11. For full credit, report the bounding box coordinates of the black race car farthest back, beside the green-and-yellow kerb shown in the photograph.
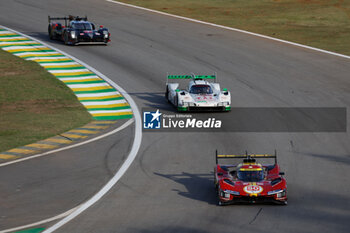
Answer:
[48,16,110,45]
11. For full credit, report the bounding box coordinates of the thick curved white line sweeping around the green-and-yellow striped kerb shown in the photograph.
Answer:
[0,25,142,233]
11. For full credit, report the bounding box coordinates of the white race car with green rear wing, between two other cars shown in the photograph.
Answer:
[165,75,231,111]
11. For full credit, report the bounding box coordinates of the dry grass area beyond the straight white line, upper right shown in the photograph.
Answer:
[120,0,350,55]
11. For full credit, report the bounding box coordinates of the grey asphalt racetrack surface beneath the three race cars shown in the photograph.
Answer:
[0,0,350,233]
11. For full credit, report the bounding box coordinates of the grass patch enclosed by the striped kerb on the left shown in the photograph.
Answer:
[0,50,92,152]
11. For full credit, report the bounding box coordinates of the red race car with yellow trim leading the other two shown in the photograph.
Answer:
[214,151,287,205]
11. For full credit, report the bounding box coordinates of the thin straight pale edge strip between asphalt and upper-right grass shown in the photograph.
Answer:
[106,0,350,59]
